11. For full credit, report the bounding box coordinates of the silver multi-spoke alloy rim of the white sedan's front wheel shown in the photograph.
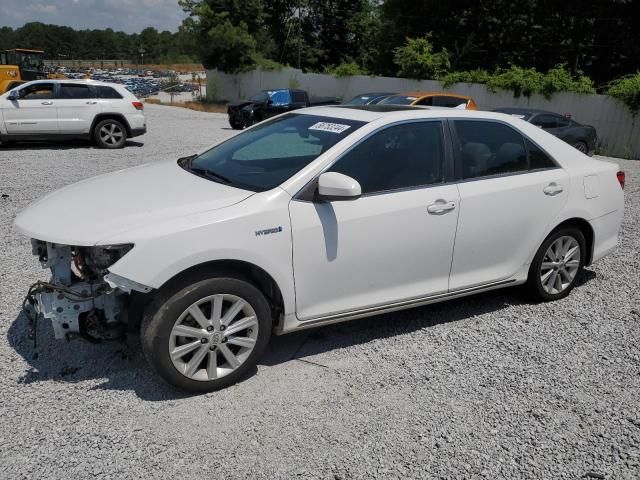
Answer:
[169,294,258,381]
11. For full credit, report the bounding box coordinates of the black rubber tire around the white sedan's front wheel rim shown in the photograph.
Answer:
[141,276,272,393]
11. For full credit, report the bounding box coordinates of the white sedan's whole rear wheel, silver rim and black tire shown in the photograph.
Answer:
[527,227,586,302]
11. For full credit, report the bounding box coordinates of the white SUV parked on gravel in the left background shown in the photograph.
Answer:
[0,80,147,148]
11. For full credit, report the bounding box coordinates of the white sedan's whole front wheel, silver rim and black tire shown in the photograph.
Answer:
[142,277,271,392]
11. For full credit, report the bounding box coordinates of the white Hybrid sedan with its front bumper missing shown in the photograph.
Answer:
[15,106,624,391]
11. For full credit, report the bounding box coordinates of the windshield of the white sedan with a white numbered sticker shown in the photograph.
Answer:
[179,113,364,192]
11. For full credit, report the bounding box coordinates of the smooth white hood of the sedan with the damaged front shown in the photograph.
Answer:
[15,160,254,246]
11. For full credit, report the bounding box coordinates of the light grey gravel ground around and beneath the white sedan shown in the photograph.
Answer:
[0,105,640,480]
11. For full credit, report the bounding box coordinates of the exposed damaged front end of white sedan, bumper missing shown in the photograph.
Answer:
[23,239,151,343]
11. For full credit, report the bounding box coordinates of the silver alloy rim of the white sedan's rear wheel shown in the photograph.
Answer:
[540,236,580,295]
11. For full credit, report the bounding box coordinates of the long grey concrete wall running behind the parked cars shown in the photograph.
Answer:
[207,68,640,159]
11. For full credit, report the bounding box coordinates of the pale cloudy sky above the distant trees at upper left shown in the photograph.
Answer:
[0,0,185,33]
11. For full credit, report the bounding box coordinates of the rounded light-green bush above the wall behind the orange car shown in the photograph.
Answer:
[393,34,451,79]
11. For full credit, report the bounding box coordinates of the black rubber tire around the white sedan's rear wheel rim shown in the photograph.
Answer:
[526,226,587,302]
